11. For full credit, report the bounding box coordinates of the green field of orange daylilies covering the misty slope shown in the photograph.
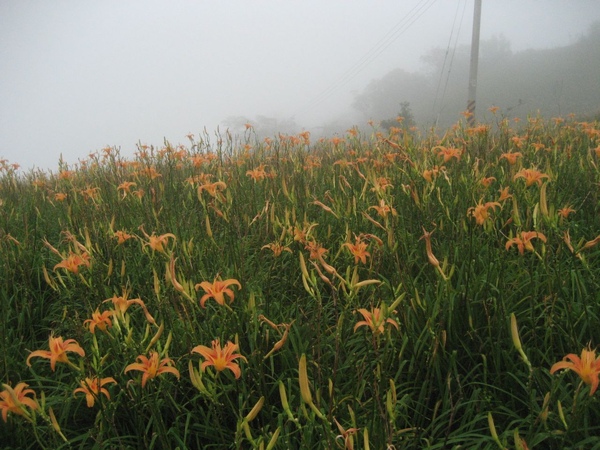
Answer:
[0,109,600,450]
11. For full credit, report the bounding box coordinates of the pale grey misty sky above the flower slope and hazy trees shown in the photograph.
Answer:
[0,0,600,171]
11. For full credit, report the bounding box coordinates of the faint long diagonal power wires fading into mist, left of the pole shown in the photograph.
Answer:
[293,0,437,115]
